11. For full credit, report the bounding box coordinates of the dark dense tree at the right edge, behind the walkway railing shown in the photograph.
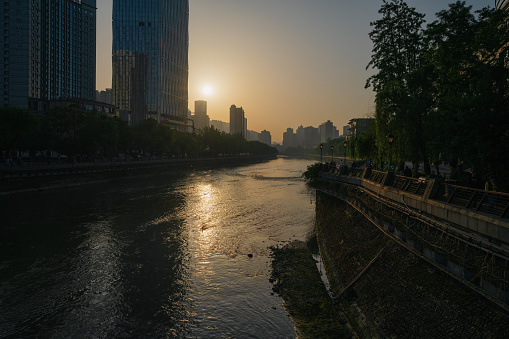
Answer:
[426,1,509,189]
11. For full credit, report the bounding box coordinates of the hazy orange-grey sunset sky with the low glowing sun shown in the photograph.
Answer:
[97,0,488,142]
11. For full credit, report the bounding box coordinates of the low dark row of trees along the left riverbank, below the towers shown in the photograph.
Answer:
[0,106,277,159]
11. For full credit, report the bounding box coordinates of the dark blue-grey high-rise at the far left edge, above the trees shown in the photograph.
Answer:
[0,0,96,110]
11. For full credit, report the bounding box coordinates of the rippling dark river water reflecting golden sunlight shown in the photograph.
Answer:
[0,158,315,338]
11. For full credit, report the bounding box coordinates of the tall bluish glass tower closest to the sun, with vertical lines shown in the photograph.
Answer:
[112,0,189,129]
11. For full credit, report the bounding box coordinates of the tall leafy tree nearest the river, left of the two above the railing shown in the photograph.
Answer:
[366,0,430,172]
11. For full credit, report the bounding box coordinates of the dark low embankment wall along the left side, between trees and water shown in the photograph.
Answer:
[0,155,277,196]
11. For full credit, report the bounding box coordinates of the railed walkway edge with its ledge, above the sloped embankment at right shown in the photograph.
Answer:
[317,165,509,311]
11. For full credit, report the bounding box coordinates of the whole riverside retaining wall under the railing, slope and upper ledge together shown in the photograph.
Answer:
[316,178,509,337]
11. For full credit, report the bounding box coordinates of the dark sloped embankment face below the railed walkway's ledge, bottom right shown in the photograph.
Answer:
[316,191,509,338]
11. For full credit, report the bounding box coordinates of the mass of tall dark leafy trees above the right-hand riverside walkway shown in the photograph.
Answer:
[342,0,509,187]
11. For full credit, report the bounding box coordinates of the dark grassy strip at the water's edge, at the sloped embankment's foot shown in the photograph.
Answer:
[271,241,351,338]
